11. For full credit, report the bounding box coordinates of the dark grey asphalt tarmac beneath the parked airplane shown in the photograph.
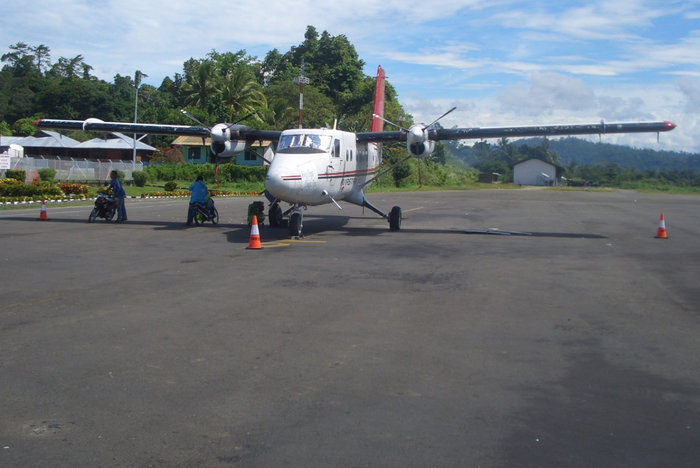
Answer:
[0,189,700,467]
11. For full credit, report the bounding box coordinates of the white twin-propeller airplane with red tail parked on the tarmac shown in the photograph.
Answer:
[35,66,676,238]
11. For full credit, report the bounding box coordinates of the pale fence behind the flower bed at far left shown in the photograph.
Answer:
[0,155,143,181]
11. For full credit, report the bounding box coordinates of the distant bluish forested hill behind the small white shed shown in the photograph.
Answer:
[513,137,700,172]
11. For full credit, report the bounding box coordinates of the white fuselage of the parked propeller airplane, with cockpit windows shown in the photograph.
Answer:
[265,129,381,206]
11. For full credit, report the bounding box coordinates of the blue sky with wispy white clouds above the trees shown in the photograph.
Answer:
[0,0,700,152]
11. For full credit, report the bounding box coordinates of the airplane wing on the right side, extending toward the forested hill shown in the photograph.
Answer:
[357,121,676,142]
